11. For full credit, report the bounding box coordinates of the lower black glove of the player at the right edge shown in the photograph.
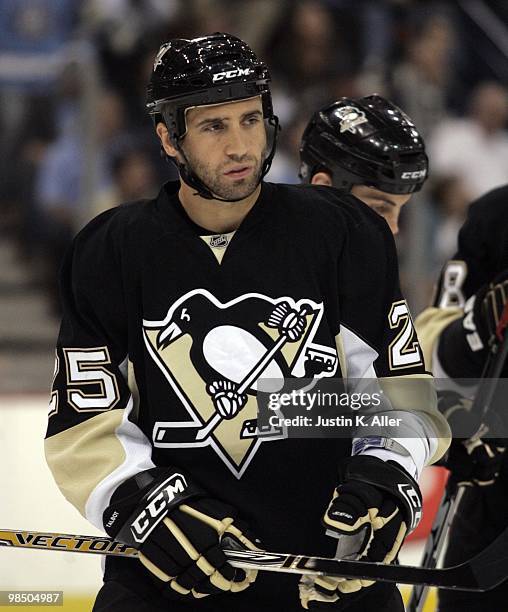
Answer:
[437,391,506,487]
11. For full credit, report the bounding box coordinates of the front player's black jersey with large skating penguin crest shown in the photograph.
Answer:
[45,183,448,610]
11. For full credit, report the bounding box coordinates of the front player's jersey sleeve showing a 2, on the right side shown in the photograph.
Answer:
[338,203,449,472]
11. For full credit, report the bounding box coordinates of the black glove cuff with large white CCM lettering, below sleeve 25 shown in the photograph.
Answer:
[103,468,205,548]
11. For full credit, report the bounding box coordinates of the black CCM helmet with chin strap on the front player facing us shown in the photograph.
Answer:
[146,32,278,199]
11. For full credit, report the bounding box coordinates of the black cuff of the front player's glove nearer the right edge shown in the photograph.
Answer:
[339,455,422,532]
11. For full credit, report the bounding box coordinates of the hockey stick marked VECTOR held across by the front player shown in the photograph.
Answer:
[0,529,508,591]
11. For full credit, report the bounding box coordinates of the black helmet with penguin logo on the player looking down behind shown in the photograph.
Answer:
[300,94,428,194]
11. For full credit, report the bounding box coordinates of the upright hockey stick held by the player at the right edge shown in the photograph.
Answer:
[408,304,508,612]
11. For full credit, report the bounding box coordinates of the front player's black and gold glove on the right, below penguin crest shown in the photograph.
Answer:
[300,455,422,611]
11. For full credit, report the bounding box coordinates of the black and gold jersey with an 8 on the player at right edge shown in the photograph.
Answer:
[416,186,508,376]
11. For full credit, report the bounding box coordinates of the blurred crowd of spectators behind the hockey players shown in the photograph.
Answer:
[0,0,508,391]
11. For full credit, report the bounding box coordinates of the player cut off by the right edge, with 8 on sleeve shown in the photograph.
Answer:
[416,186,508,612]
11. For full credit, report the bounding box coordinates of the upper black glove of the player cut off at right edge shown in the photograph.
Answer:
[438,270,508,378]
